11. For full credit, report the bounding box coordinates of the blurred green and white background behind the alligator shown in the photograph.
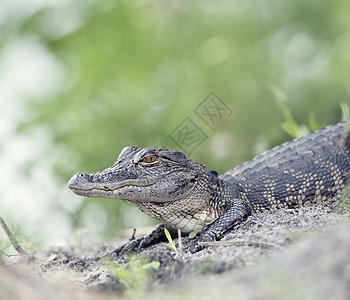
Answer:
[0,0,350,244]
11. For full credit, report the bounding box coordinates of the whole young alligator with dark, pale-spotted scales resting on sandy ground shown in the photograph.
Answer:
[68,122,350,254]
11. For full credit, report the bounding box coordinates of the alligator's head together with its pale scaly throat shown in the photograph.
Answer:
[68,146,227,233]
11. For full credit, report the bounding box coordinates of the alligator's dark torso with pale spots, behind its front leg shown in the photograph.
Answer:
[221,122,350,211]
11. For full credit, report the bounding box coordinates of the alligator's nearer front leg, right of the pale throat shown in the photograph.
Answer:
[187,199,252,253]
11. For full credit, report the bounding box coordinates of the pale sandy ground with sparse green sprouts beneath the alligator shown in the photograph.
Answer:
[0,197,350,300]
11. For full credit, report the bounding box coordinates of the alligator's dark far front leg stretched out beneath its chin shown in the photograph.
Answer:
[111,224,177,256]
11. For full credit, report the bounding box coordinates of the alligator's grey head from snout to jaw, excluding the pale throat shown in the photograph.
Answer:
[68,146,212,202]
